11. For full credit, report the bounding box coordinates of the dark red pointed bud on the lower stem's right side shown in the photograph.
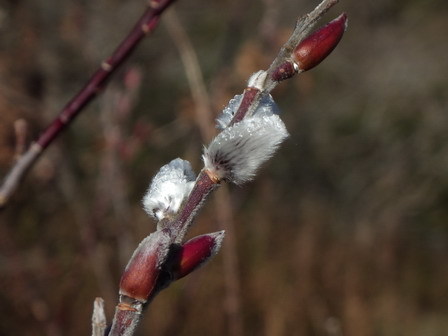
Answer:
[172,231,225,279]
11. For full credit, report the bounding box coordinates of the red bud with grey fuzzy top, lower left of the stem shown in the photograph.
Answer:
[120,230,170,302]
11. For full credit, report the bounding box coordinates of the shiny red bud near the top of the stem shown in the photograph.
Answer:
[292,13,347,72]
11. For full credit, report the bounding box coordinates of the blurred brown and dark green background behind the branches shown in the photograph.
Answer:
[0,0,448,336]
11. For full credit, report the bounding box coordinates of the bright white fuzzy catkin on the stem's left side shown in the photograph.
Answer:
[143,159,196,221]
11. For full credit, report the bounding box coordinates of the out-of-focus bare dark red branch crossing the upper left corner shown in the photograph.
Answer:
[0,0,175,208]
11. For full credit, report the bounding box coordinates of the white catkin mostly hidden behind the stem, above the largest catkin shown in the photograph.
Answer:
[216,94,280,131]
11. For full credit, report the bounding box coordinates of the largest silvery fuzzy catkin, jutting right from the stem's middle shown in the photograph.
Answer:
[202,114,288,184]
